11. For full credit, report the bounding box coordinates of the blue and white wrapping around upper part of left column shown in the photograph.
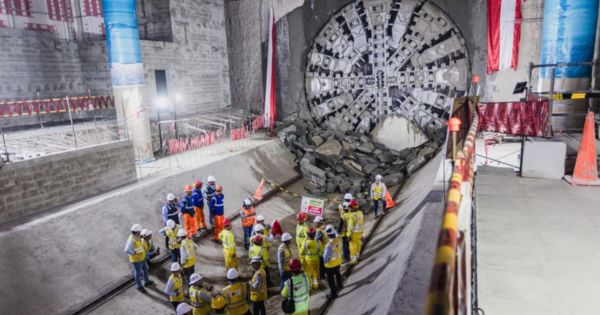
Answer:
[102,0,144,87]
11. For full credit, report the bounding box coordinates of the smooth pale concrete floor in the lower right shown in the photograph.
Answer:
[476,167,600,314]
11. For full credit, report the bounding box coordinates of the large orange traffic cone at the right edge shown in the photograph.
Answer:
[565,112,600,186]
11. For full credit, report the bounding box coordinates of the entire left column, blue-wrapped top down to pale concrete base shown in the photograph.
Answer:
[102,0,154,163]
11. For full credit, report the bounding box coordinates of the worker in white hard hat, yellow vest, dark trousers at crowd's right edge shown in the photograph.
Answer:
[323,225,342,299]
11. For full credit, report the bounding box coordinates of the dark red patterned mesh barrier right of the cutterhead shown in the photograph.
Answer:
[477,100,549,137]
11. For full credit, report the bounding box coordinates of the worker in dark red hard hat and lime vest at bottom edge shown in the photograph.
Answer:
[281,258,311,315]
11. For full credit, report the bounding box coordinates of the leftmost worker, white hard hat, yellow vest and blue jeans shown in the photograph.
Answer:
[125,224,154,292]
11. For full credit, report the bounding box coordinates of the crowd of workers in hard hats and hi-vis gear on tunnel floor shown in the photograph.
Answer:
[125,175,387,315]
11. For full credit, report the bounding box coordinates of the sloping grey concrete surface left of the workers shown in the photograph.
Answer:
[0,141,297,314]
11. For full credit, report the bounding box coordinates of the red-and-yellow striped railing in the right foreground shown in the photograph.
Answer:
[425,110,479,315]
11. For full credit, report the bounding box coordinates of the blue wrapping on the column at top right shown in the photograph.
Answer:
[540,0,598,78]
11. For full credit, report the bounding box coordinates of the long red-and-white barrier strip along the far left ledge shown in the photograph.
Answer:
[0,95,115,118]
